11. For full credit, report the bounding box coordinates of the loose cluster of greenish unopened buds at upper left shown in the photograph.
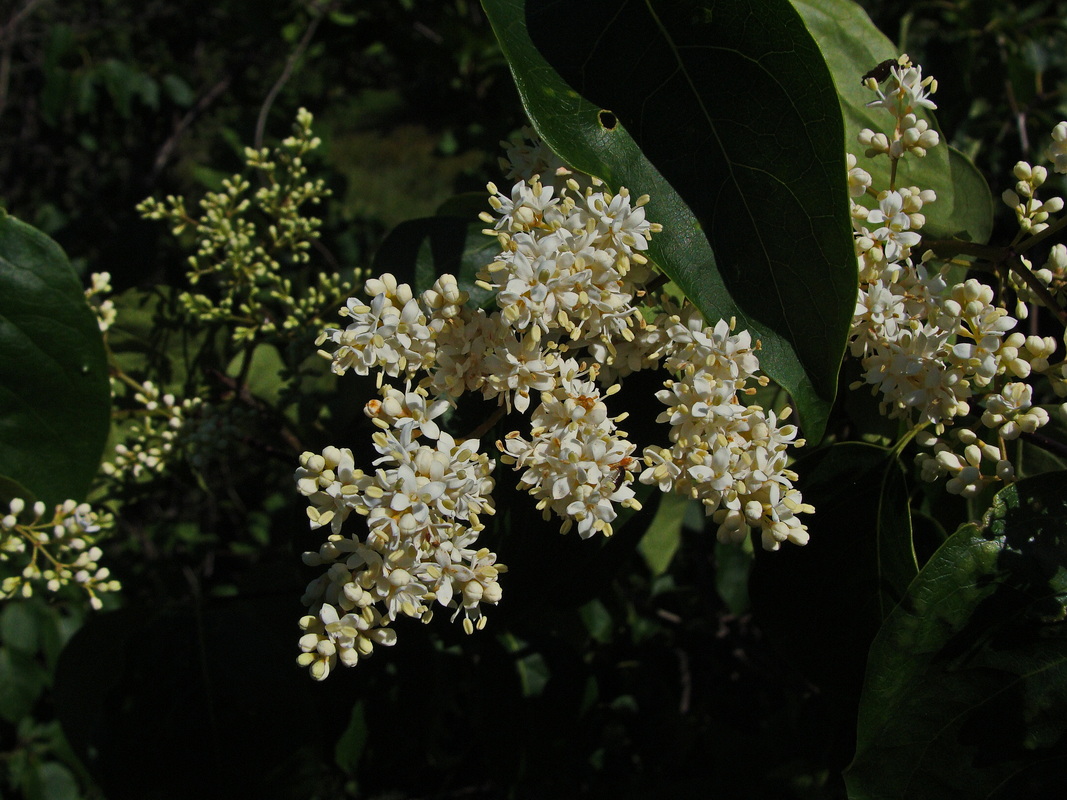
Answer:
[138,109,356,342]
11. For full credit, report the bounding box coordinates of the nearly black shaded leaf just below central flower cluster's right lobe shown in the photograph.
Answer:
[748,443,917,695]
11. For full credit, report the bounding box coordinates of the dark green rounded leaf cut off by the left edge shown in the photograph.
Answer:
[0,212,111,503]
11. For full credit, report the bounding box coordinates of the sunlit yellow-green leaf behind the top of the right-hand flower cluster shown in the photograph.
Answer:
[793,0,993,242]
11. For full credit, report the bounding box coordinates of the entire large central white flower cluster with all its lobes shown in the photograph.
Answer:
[297,134,812,679]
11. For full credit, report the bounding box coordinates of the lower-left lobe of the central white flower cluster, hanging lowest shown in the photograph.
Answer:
[297,413,507,681]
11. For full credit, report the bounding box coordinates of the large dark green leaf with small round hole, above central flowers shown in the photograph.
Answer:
[482,0,856,439]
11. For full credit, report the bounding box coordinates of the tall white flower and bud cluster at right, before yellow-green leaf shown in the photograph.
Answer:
[848,55,1063,496]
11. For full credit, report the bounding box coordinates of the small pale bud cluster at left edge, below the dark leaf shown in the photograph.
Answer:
[0,497,122,609]
